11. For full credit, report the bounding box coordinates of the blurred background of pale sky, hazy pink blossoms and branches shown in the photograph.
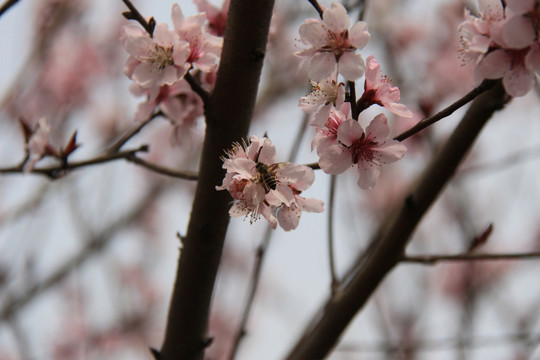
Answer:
[0,0,540,360]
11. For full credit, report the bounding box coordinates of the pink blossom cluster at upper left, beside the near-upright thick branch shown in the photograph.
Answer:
[120,0,224,142]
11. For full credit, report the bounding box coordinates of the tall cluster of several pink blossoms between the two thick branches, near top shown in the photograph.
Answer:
[297,3,413,189]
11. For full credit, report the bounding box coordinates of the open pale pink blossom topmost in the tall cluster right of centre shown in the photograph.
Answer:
[295,3,370,81]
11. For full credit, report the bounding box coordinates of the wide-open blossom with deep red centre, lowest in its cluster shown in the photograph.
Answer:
[319,114,407,189]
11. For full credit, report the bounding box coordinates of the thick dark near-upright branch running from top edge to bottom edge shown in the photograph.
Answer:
[161,0,273,360]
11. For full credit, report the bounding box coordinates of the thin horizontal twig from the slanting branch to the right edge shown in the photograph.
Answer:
[400,252,540,265]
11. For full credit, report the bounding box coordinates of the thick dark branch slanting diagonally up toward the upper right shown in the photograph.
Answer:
[287,83,506,360]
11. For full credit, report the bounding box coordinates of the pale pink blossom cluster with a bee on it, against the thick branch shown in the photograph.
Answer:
[216,136,324,231]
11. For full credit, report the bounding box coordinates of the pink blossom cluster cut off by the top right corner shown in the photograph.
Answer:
[460,0,540,96]
